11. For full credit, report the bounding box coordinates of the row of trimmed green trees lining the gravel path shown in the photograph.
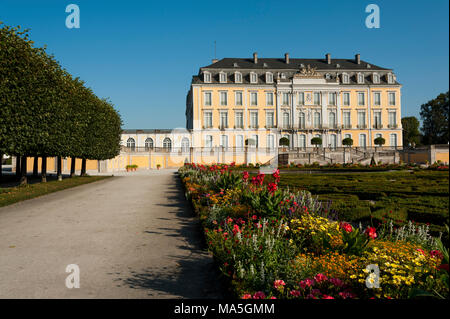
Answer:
[0,22,122,183]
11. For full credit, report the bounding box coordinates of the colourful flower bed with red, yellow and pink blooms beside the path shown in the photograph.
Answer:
[179,164,448,299]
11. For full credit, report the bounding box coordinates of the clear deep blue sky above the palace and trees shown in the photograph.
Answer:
[0,0,449,128]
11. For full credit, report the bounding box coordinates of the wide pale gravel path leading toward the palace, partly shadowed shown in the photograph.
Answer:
[0,170,223,298]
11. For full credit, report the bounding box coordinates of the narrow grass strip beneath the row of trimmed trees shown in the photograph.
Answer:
[0,176,110,207]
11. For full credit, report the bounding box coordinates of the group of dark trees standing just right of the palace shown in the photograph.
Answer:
[402,92,449,146]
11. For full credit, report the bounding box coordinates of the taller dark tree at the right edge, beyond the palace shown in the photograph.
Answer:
[420,92,449,144]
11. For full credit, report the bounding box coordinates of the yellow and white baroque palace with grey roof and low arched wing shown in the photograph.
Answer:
[114,53,402,169]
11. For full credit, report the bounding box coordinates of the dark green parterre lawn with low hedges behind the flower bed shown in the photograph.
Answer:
[279,170,449,232]
